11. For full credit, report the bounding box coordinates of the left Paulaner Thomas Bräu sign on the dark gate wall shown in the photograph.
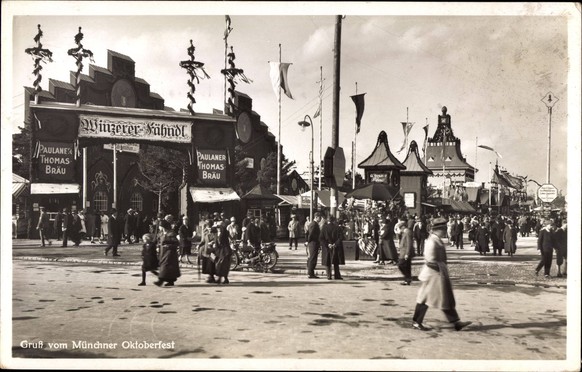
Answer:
[37,141,75,182]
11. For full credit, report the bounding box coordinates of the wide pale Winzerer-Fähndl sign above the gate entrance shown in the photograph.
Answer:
[79,115,192,143]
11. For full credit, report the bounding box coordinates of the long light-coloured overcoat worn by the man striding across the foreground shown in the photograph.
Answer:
[416,234,456,310]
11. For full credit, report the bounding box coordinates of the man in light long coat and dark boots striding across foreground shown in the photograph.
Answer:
[412,218,472,331]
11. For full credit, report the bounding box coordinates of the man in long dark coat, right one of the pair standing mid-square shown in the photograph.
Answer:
[319,216,346,280]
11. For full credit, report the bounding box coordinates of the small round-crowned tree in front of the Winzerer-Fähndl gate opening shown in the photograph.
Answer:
[137,145,188,213]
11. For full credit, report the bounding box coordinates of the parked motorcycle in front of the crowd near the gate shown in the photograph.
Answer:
[230,240,279,273]
